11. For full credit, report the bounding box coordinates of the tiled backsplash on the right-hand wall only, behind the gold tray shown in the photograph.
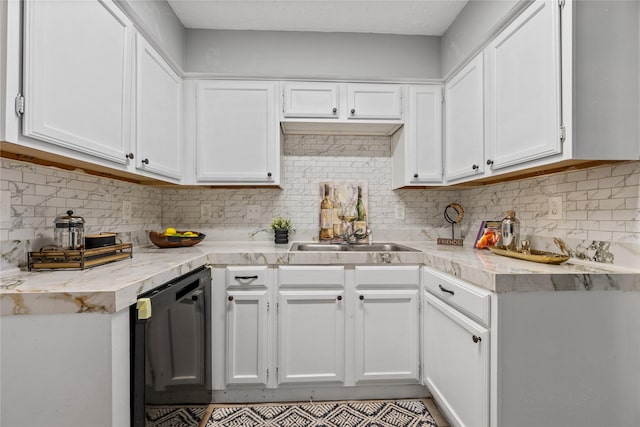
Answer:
[461,161,640,268]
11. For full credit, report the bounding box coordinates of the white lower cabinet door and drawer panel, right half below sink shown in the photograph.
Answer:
[354,266,420,383]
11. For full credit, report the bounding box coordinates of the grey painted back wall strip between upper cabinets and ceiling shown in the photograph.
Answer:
[185,30,440,81]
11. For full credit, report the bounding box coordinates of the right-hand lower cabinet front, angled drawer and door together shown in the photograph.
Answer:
[422,268,491,427]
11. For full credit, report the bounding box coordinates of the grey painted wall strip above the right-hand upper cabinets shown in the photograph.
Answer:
[441,0,529,77]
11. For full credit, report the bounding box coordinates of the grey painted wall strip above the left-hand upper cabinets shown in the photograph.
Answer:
[124,0,186,69]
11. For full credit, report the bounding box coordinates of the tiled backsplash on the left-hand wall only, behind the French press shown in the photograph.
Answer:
[0,159,162,268]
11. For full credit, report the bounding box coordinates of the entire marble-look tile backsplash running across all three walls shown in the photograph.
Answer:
[0,150,640,268]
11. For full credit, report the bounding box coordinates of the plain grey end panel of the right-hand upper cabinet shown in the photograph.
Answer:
[573,0,640,158]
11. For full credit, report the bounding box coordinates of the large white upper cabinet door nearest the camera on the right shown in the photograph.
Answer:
[486,0,562,169]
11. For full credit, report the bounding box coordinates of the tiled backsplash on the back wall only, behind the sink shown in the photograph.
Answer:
[162,135,460,240]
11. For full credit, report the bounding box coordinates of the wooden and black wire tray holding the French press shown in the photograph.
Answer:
[28,243,133,271]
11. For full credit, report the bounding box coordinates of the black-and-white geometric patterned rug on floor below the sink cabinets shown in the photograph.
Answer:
[205,400,436,427]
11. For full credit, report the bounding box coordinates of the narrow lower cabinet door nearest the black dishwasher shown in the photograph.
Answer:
[226,289,268,386]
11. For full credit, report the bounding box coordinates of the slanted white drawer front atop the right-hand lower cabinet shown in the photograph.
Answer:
[424,268,491,326]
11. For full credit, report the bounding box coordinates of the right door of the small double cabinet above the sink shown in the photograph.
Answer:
[347,84,402,120]
